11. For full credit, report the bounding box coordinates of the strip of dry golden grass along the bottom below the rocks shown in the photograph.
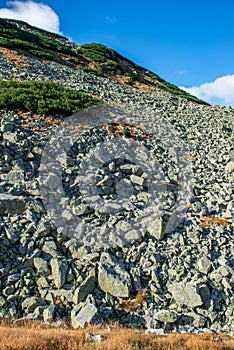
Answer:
[0,324,234,350]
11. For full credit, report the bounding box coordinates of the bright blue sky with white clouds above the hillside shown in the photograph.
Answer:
[0,0,234,106]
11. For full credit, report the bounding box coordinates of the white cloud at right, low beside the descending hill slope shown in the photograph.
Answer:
[180,74,234,107]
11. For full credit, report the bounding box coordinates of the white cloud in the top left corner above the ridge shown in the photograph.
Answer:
[0,0,62,34]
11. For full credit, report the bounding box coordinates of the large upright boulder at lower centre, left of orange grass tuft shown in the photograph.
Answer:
[98,253,131,298]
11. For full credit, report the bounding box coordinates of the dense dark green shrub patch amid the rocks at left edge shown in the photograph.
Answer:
[0,81,100,116]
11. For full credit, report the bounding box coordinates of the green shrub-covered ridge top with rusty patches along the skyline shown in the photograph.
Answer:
[0,19,207,104]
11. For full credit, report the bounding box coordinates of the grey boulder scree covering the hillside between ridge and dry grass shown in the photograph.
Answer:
[0,20,234,334]
